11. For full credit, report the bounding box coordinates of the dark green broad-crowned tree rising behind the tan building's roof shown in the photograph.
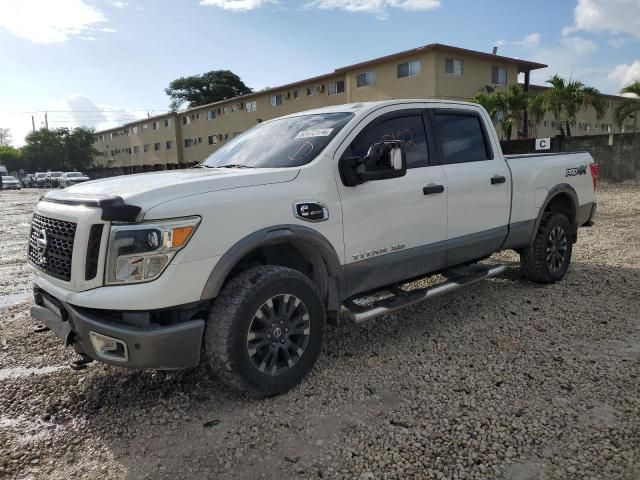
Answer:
[165,70,252,111]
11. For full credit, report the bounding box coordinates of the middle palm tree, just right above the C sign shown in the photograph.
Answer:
[542,74,605,137]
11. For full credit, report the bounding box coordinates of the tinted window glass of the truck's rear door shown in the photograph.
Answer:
[434,113,492,163]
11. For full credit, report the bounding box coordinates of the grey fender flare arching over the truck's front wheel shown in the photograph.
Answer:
[200,224,344,310]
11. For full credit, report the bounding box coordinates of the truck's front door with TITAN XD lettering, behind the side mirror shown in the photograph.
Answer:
[334,104,447,294]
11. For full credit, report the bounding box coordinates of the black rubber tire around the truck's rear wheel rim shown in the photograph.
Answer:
[520,212,573,283]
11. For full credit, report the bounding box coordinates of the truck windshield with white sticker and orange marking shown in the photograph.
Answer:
[202,112,353,168]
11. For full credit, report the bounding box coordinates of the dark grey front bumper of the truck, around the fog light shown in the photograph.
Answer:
[31,291,204,370]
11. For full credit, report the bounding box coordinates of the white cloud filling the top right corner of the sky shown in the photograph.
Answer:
[563,0,640,37]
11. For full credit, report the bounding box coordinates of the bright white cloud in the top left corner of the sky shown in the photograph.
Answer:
[0,0,107,44]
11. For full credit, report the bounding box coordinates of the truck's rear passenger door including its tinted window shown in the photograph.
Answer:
[430,107,511,265]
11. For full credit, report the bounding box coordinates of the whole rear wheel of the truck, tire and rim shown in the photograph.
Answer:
[520,212,573,283]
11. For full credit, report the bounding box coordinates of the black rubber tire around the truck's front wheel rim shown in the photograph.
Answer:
[203,265,325,398]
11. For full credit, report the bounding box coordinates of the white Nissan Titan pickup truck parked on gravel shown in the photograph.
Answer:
[28,100,598,396]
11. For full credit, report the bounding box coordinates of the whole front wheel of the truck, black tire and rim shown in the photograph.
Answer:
[204,265,325,397]
